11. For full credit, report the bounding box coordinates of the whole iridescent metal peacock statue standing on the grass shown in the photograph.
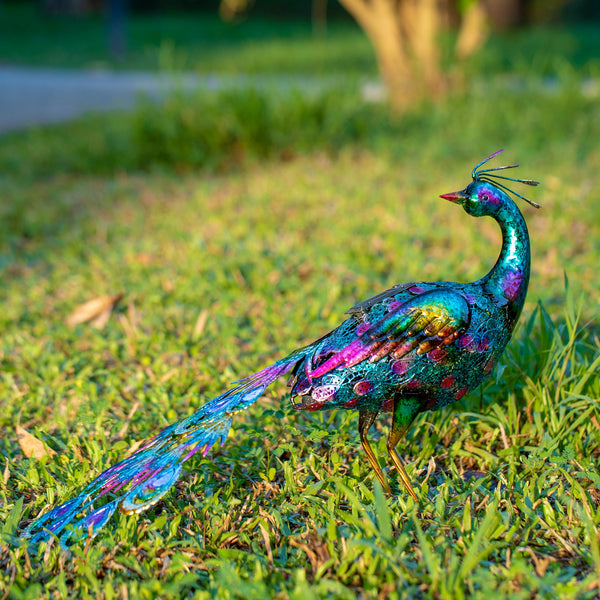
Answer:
[25,151,539,542]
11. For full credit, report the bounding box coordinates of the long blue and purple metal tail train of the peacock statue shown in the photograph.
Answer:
[24,349,306,544]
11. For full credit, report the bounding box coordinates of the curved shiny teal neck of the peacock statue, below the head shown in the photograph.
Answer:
[478,200,531,325]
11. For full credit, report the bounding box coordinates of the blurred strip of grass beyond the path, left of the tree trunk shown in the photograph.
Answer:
[0,3,377,76]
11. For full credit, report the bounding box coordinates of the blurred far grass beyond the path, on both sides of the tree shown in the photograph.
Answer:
[0,2,600,79]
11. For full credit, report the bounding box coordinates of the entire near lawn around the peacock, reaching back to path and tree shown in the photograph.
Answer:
[0,5,600,599]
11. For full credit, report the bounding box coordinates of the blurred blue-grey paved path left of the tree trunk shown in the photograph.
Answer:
[0,66,335,134]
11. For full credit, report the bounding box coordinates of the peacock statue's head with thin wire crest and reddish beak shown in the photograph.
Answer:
[440,150,540,217]
